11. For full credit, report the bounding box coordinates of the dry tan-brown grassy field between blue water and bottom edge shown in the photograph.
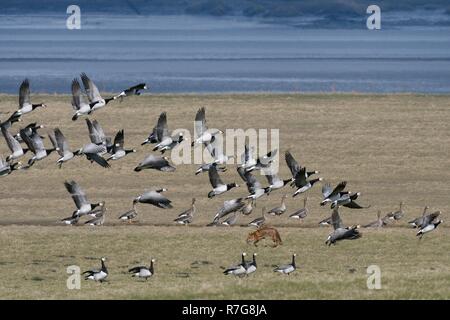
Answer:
[0,94,450,299]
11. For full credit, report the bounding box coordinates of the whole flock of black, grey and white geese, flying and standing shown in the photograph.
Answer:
[0,73,442,281]
